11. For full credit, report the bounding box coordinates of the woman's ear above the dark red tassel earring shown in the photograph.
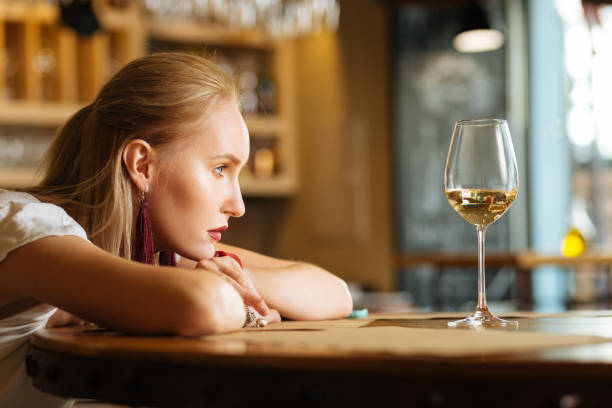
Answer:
[122,139,155,193]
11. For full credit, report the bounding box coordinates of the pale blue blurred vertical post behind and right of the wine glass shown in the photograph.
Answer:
[528,0,571,312]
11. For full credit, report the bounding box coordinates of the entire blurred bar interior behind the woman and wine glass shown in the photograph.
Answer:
[0,0,612,312]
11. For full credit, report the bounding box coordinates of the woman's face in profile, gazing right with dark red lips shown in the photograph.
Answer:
[149,101,249,261]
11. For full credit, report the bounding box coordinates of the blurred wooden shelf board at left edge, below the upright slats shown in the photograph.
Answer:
[0,101,82,127]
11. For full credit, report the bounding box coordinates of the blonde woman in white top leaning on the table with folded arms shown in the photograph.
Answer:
[0,53,352,407]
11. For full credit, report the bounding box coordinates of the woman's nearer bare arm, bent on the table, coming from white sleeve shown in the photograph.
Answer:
[0,236,245,335]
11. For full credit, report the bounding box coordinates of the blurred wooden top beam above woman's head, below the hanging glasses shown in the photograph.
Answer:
[146,18,275,49]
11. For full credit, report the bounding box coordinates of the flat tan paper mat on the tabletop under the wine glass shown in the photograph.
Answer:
[205,321,607,357]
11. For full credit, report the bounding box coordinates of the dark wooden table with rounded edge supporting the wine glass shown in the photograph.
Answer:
[27,311,612,408]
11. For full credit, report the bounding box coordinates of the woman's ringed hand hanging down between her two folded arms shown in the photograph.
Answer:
[195,256,270,322]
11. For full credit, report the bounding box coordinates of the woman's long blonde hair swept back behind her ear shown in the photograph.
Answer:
[28,52,239,259]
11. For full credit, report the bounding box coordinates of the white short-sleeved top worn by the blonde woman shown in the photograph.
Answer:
[0,189,87,408]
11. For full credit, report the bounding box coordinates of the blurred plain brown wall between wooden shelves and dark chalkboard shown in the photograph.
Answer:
[225,0,395,290]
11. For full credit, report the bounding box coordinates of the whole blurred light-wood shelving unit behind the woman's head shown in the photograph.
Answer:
[0,0,297,196]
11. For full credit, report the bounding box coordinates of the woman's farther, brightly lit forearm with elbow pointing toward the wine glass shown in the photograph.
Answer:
[181,244,353,320]
